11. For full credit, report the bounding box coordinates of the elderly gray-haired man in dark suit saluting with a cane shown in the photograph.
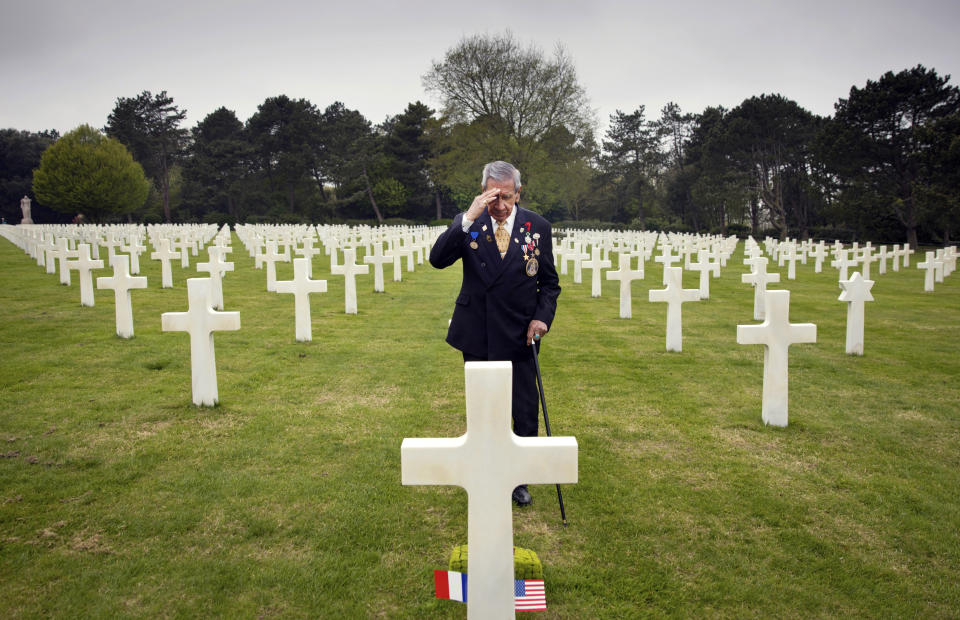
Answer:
[430,161,560,506]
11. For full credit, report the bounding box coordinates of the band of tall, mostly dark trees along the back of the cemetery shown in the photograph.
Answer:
[0,32,960,245]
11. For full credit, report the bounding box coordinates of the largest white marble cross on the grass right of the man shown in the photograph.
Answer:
[737,291,817,426]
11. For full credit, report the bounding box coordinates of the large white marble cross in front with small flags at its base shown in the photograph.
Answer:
[400,362,577,620]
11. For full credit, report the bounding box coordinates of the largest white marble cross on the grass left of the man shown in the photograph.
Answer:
[160,278,240,407]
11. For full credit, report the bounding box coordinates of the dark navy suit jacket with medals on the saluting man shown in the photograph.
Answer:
[430,206,560,360]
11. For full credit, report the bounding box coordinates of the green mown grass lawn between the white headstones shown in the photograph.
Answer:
[0,230,960,618]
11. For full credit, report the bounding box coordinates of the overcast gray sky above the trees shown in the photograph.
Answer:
[0,0,960,133]
